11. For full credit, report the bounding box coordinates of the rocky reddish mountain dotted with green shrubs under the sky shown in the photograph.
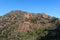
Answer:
[0,10,60,40]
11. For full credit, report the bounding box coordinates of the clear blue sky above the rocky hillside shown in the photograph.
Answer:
[0,0,60,18]
